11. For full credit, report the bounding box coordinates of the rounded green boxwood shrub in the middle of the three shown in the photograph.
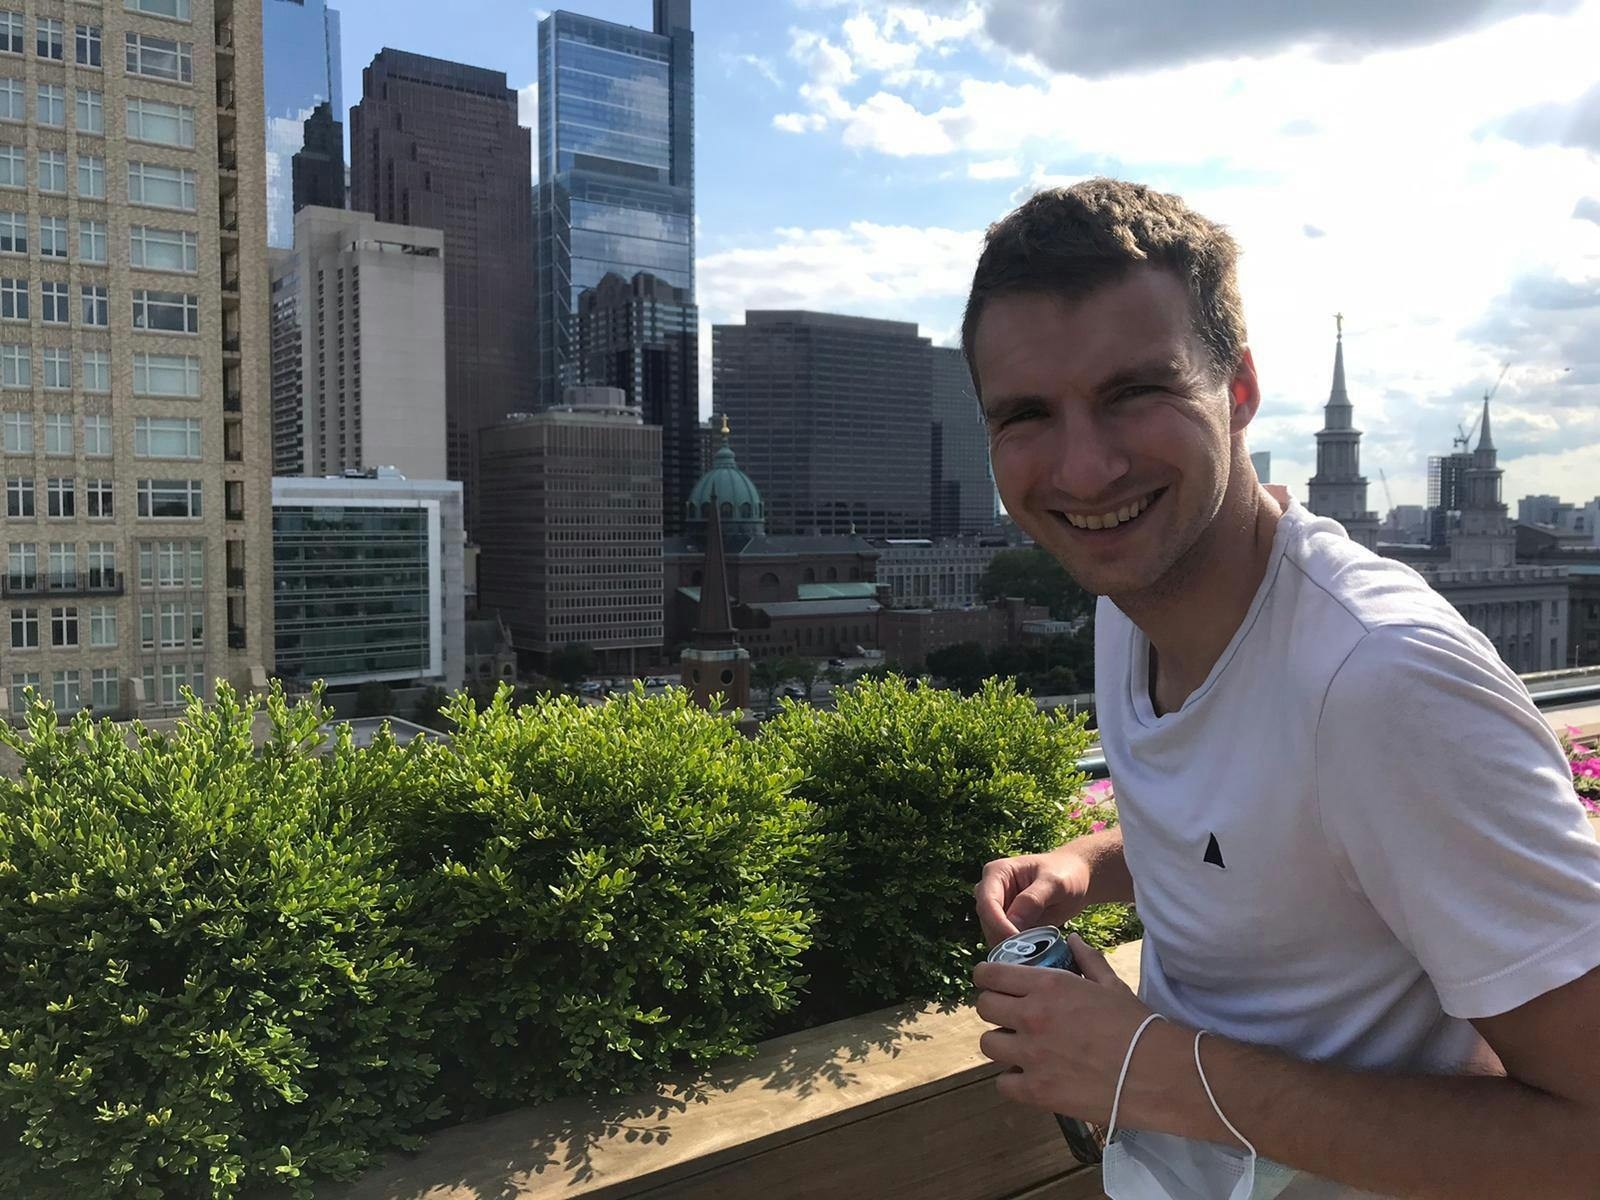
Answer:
[382,686,818,1117]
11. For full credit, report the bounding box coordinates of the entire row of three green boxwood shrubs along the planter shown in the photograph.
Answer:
[0,678,1113,1200]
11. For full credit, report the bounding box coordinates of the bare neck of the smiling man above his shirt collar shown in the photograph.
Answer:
[1112,486,1282,714]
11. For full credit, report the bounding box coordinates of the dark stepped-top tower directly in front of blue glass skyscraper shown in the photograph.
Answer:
[578,272,701,536]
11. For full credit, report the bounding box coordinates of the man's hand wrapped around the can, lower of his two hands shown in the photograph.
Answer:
[973,934,1150,1125]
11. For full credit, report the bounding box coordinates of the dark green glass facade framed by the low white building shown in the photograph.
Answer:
[272,504,434,683]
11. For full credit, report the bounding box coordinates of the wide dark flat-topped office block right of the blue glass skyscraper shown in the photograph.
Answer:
[712,312,933,538]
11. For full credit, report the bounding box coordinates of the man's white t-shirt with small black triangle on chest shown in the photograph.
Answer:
[1094,504,1600,1195]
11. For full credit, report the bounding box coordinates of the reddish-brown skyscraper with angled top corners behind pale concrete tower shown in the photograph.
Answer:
[350,50,534,541]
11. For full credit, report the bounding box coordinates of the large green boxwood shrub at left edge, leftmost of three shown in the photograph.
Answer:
[0,686,438,1200]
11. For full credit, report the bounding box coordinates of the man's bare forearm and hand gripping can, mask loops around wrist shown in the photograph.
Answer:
[974,941,1600,1200]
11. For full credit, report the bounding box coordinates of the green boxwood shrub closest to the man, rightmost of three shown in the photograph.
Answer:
[763,677,1130,1021]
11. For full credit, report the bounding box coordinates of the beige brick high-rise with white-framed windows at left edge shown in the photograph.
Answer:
[0,0,272,715]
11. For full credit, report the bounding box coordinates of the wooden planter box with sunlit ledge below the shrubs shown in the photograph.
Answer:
[317,942,1139,1200]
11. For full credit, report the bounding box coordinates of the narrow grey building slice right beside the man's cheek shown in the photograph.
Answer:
[930,346,995,538]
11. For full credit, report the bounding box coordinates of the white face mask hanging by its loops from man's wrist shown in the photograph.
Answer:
[1101,1013,1298,1200]
